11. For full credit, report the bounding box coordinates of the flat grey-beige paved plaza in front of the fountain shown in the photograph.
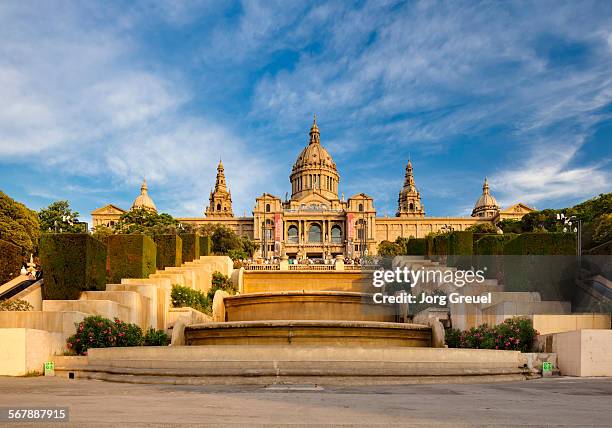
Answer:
[0,377,612,426]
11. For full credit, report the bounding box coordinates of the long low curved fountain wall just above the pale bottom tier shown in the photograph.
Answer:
[185,320,431,347]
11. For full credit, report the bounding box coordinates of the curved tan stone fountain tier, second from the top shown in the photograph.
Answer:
[223,291,397,322]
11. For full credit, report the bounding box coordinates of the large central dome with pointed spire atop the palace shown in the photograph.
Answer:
[289,116,340,200]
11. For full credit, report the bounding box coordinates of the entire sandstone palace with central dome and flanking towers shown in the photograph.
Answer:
[92,116,533,259]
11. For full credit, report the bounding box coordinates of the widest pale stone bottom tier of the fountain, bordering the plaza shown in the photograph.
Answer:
[54,345,528,385]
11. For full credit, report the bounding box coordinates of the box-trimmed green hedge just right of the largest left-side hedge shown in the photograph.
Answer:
[108,235,157,283]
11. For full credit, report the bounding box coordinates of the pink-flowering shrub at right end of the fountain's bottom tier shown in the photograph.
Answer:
[446,317,538,352]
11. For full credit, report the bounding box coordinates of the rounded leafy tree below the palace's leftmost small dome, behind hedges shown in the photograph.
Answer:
[113,208,179,235]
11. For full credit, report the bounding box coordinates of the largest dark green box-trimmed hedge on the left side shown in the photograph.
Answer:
[39,233,106,300]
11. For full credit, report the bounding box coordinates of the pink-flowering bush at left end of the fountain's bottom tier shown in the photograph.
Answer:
[66,315,143,355]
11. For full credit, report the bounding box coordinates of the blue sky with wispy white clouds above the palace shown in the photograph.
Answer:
[0,0,612,224]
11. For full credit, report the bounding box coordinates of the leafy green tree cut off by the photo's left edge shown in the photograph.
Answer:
[0,191,40,252]
